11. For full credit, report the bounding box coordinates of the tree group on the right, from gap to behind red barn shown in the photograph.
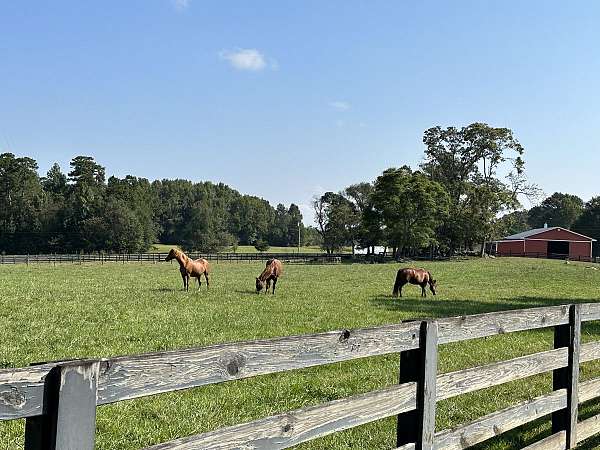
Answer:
[313,123,600,257]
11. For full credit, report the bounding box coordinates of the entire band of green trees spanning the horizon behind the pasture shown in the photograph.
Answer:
[5,123,600,256]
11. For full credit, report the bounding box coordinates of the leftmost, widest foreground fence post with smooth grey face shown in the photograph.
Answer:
[25,360,100,450]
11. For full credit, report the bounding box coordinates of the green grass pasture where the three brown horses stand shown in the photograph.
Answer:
[0,258,600,449]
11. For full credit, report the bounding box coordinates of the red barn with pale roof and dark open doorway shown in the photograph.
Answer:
[495,227,595,261]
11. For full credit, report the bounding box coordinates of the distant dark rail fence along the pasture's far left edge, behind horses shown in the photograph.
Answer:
[0,252,352,264]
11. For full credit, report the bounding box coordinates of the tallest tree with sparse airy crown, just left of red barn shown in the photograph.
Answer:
[421,123,538,253]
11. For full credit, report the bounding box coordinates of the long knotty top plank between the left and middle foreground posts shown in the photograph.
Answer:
[98,322,421,404]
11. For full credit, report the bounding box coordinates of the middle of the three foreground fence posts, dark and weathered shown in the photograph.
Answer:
[396,321,438,450]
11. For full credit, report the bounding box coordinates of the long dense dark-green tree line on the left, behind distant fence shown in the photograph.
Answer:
[0,153,318,254]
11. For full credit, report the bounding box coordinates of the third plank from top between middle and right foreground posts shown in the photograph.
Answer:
[434,389,567,450]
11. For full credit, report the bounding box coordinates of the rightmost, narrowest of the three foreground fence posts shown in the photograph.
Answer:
[552,305,581,448]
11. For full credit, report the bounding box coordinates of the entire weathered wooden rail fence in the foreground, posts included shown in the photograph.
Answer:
[0,303,600,450]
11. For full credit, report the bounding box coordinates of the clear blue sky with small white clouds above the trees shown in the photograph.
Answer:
[0,0,600,222]
